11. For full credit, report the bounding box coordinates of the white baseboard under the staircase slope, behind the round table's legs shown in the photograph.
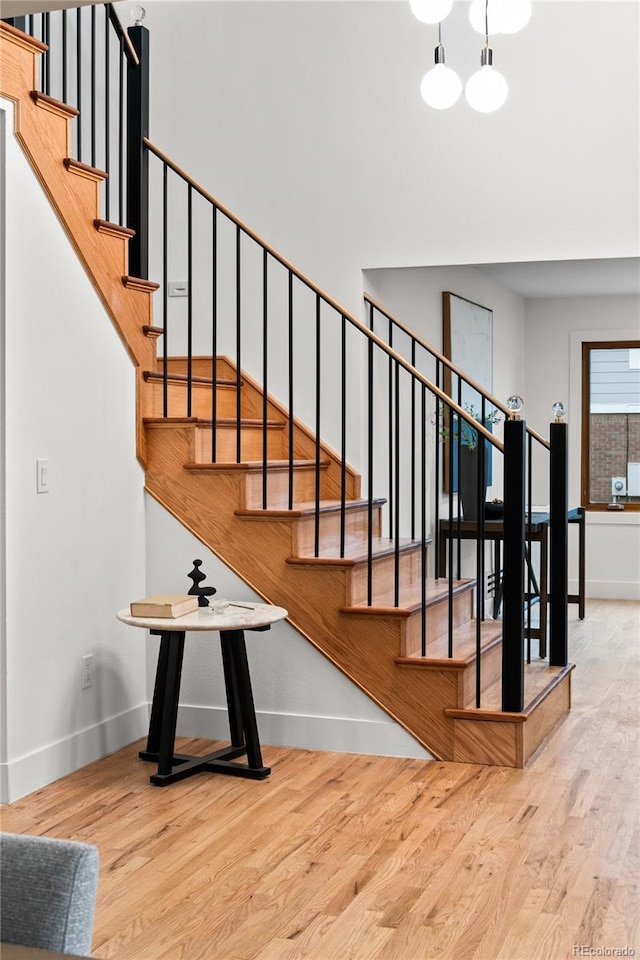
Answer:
[177,706,433,760]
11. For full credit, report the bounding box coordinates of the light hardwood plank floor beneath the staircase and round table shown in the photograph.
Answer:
[2,601,640,960]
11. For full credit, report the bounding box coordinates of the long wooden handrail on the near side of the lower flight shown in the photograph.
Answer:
[143,137,504,453]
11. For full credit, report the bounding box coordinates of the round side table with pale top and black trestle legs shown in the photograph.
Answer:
[118,602,287,787]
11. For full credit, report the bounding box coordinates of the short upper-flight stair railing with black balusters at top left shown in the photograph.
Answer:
[6,3,140,232]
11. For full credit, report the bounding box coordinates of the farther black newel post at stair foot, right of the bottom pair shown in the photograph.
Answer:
[549,423,569,667]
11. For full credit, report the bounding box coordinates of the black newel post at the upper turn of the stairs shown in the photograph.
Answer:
[127,24,149,280]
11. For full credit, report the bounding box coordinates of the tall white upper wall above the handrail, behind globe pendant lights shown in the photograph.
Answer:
[118,0,640,311]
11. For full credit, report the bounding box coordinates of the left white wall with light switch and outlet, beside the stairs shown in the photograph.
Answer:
[0,101,147,800]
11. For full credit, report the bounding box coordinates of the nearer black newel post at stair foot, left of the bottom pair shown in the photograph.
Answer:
[502,420,525,713]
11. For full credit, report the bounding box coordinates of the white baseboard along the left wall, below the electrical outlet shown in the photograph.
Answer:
[0,703,149,803]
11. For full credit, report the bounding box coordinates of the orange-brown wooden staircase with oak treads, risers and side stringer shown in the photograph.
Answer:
[0,16,572,767]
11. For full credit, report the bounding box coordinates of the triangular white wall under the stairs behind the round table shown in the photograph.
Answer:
[146,496,430,758]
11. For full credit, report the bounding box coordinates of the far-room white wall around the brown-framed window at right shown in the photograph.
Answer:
[525,296,640,600]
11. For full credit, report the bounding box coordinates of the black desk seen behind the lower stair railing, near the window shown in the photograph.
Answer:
[438,507,586,657]
